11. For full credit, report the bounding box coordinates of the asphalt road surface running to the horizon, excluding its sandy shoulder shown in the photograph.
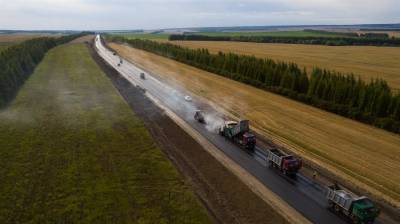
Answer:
[96,36,381,224]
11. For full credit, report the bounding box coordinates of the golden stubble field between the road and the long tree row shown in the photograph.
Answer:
[110,44,400,206]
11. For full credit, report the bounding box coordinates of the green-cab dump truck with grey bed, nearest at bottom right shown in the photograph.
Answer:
[326,184,380,224]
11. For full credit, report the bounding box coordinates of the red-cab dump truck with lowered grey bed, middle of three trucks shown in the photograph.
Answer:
[267,149,303,175]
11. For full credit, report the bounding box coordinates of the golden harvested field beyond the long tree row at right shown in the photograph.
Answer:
[163,41,400,89]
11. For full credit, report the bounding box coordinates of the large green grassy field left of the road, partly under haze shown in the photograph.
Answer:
[0,43,210,223]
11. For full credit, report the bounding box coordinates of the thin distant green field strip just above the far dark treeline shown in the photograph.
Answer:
[193,31,344,37]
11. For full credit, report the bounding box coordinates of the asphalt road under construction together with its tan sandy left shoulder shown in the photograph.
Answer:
[96,36,392,223]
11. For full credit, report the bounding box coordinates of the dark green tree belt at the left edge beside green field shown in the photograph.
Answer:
[0,33,88,108]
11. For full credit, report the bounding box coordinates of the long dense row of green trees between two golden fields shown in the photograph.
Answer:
[108,36,400,133]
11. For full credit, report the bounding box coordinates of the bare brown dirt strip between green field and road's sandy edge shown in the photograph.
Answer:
[87,41,287,223]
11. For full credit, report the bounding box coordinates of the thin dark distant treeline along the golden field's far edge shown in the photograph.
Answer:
[169,34,400,46]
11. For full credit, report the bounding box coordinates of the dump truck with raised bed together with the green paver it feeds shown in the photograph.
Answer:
[219,120,256,150]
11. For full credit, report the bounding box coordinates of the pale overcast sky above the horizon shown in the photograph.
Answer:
[0,0,400,30]
